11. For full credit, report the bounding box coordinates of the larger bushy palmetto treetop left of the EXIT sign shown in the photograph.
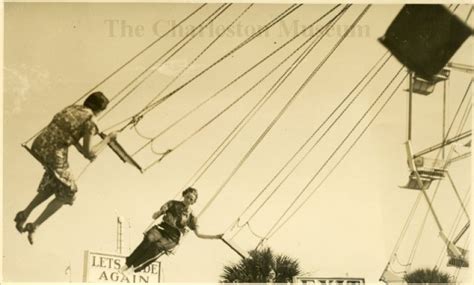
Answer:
[221,248,300,283]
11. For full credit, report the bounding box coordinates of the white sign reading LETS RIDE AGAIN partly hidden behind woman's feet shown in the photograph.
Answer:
[82,250,161,283]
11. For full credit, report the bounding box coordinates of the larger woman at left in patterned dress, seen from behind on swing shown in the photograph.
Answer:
[14,92,117,244]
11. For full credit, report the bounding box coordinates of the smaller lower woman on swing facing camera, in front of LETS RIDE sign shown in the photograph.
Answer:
[120,187,223,272]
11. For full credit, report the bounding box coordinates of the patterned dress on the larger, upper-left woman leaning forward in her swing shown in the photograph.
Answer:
[31,105,98,205]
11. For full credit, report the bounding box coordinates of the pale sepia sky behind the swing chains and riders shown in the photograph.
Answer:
[3,3,473,282]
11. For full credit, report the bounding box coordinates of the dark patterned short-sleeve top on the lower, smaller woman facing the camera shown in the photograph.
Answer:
[160,200,198,233]
